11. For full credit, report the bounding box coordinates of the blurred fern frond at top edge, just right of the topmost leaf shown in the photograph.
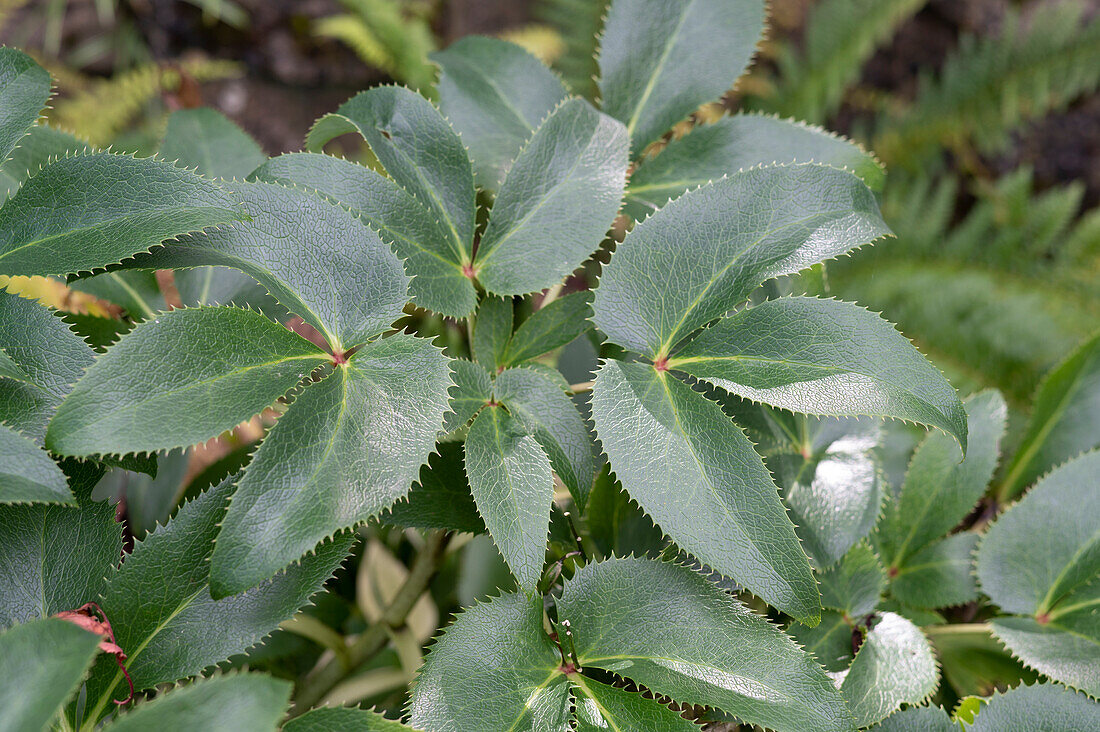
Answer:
[761,0,927,123]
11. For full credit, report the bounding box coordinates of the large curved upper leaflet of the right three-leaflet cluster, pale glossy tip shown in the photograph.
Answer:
[593,165,900,358]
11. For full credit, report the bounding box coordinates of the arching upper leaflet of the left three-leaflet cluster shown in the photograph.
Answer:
[124,183,408,350]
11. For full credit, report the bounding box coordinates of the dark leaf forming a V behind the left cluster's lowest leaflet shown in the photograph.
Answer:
[88,473,353,718]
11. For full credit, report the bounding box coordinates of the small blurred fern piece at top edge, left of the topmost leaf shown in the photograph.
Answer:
[535,0,608,99]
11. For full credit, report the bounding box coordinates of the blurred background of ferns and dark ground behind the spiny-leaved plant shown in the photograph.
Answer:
[0,0,1100,707]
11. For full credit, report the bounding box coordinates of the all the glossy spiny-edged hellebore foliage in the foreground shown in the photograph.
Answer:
[0,0,1100,730]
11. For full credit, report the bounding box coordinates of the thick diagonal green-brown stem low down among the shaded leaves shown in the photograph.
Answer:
[290,532,450,717]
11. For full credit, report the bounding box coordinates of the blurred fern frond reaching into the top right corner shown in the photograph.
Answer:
[873,0,1100,168]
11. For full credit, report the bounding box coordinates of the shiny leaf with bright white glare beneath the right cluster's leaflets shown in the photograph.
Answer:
[768,419,884,568]
